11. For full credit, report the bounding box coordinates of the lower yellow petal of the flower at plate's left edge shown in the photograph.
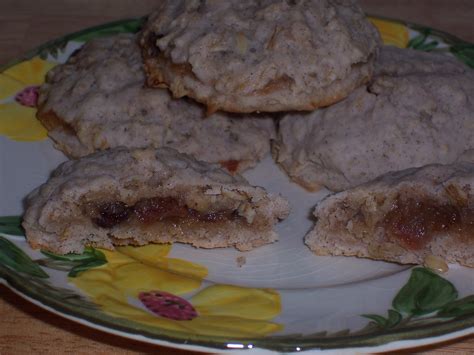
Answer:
[0,103,47,142]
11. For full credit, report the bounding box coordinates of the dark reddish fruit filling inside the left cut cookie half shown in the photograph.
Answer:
[84,197,245,228]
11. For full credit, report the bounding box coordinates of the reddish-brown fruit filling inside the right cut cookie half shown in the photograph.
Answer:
[381,198,474,250]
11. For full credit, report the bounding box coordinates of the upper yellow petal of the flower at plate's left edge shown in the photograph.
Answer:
[3,57,57,85]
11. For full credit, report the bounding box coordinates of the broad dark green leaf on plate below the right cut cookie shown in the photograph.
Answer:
[392,268,458,316]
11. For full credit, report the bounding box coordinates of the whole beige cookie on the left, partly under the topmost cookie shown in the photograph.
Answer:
[38,34,275,171]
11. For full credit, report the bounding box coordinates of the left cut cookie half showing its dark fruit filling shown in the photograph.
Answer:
[23,147,289,254]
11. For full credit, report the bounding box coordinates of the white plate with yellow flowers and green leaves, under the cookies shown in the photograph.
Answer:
[0,18,474,353]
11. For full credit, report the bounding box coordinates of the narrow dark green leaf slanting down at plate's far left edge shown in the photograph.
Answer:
[0,237,49,278]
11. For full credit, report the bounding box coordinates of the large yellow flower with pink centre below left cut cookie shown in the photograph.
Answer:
[69,245,282,338]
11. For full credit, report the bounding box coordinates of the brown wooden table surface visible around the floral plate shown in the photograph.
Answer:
[0,0,474,355]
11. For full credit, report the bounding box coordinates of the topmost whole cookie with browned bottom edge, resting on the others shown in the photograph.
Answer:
[140,0,380,112]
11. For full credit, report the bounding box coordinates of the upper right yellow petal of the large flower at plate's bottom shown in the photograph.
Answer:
[191,285,281,320]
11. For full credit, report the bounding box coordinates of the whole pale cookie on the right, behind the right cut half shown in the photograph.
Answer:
[273,47,474,191]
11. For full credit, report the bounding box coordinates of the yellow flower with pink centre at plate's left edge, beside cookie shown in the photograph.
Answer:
[0,57,56,141]
